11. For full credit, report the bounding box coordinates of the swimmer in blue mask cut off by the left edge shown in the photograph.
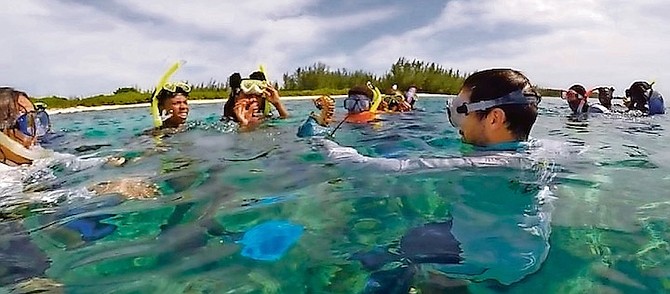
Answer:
[0,87,156,287]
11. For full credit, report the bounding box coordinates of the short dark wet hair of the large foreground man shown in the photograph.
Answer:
[461,68,541,140]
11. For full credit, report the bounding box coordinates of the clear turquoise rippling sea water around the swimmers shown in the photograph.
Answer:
[1,98,670,293]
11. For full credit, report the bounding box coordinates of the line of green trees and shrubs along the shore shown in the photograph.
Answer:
[33,57,555,108]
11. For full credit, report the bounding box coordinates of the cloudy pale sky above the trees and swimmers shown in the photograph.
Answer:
[0,0,670,97]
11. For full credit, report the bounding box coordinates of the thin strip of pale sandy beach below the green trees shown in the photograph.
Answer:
[47,93,452,114]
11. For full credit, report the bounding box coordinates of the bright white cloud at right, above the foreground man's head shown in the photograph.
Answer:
[342,0,670,95]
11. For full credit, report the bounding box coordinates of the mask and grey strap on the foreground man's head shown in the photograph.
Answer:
[447,90,540,129]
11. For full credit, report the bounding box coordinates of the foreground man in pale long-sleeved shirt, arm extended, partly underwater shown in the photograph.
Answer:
[300,69,553,293]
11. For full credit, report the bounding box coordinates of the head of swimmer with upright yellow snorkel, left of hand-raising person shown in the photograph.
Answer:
[157,82,191,128]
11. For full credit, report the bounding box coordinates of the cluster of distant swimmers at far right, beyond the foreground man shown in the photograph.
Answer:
[563,81,665,115]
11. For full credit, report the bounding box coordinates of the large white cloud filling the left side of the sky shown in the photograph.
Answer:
[0,0,395,96]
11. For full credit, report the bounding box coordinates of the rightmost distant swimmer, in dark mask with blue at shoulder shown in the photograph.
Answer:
[626,81,665,115]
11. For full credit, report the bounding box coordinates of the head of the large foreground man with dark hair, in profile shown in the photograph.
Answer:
[448,68,541,146]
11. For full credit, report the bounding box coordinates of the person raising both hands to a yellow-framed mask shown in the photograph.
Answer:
[222,71,289,127]
